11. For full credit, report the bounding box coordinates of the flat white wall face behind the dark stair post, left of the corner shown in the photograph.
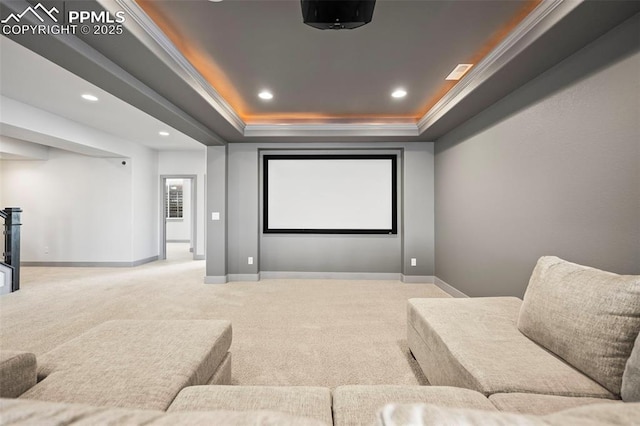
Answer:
[1,149,133,262]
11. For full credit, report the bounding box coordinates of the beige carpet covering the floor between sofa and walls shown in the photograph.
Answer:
[0,245,448,387]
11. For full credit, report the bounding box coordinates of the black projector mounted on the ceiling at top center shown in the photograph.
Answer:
[301,0,376,30]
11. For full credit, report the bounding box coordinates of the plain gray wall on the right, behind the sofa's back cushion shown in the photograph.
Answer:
[435,16,640,296]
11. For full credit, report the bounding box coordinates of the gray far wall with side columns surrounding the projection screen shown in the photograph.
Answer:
[207,143,434,282]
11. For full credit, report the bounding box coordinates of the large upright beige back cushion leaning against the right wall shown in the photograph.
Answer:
[518,256,640,395]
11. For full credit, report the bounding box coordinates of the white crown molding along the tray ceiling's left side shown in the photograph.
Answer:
[109,0,246,133]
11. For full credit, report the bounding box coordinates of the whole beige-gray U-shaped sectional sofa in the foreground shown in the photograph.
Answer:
[0,257,640,426]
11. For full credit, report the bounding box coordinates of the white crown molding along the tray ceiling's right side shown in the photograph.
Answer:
[417,0,583,134]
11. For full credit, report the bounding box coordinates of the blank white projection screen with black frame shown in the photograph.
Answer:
[263,155,397,234]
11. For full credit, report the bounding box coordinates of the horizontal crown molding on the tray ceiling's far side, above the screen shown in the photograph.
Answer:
[244,123,420,137]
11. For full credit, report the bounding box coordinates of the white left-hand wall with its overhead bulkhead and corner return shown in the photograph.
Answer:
[0,97,159,266]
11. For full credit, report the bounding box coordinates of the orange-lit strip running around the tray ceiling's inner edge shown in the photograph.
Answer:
[136,0,542,124]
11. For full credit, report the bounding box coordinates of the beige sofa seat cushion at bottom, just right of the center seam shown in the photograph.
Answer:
[333,385,496,426]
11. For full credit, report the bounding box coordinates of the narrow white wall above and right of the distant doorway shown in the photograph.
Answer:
[157,151,207,259]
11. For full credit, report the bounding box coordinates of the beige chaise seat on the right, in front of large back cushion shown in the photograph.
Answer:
[407,297,615,398]
